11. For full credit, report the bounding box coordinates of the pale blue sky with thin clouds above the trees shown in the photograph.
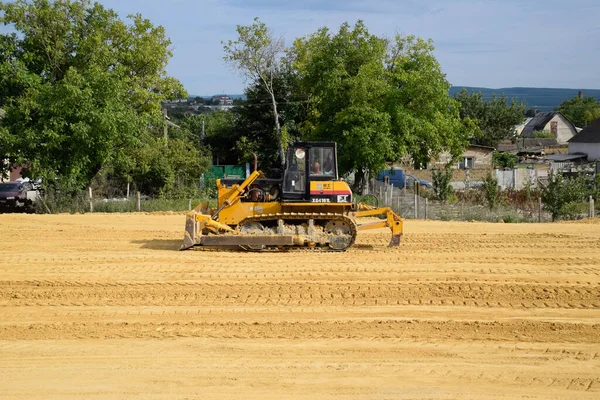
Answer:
[5,0,600,95]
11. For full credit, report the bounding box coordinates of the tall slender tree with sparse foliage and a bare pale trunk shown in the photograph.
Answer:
[223,18,287,165]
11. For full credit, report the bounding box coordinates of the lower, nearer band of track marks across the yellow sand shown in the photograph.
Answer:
[0,319,600,343]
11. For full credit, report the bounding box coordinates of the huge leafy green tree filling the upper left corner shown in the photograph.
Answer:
[0,0,187,190]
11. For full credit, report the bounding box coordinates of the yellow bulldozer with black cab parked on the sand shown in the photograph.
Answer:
[181,142,403,251]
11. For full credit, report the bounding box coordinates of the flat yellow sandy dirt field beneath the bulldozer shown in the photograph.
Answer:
[0,214,600,399]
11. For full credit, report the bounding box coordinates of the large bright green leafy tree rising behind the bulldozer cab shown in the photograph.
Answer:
[289,21,467,192]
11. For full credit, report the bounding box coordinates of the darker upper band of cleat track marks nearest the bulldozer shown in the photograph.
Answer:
[0,281,600,309]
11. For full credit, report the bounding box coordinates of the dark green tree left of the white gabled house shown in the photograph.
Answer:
[454,89,525,147]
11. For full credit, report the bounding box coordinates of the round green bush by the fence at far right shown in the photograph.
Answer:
[541,172,587,221]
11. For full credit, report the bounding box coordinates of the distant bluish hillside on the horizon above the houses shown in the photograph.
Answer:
[450,86,600,111]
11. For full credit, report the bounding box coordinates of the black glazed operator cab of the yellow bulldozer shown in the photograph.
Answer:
[283,142,338,201]
